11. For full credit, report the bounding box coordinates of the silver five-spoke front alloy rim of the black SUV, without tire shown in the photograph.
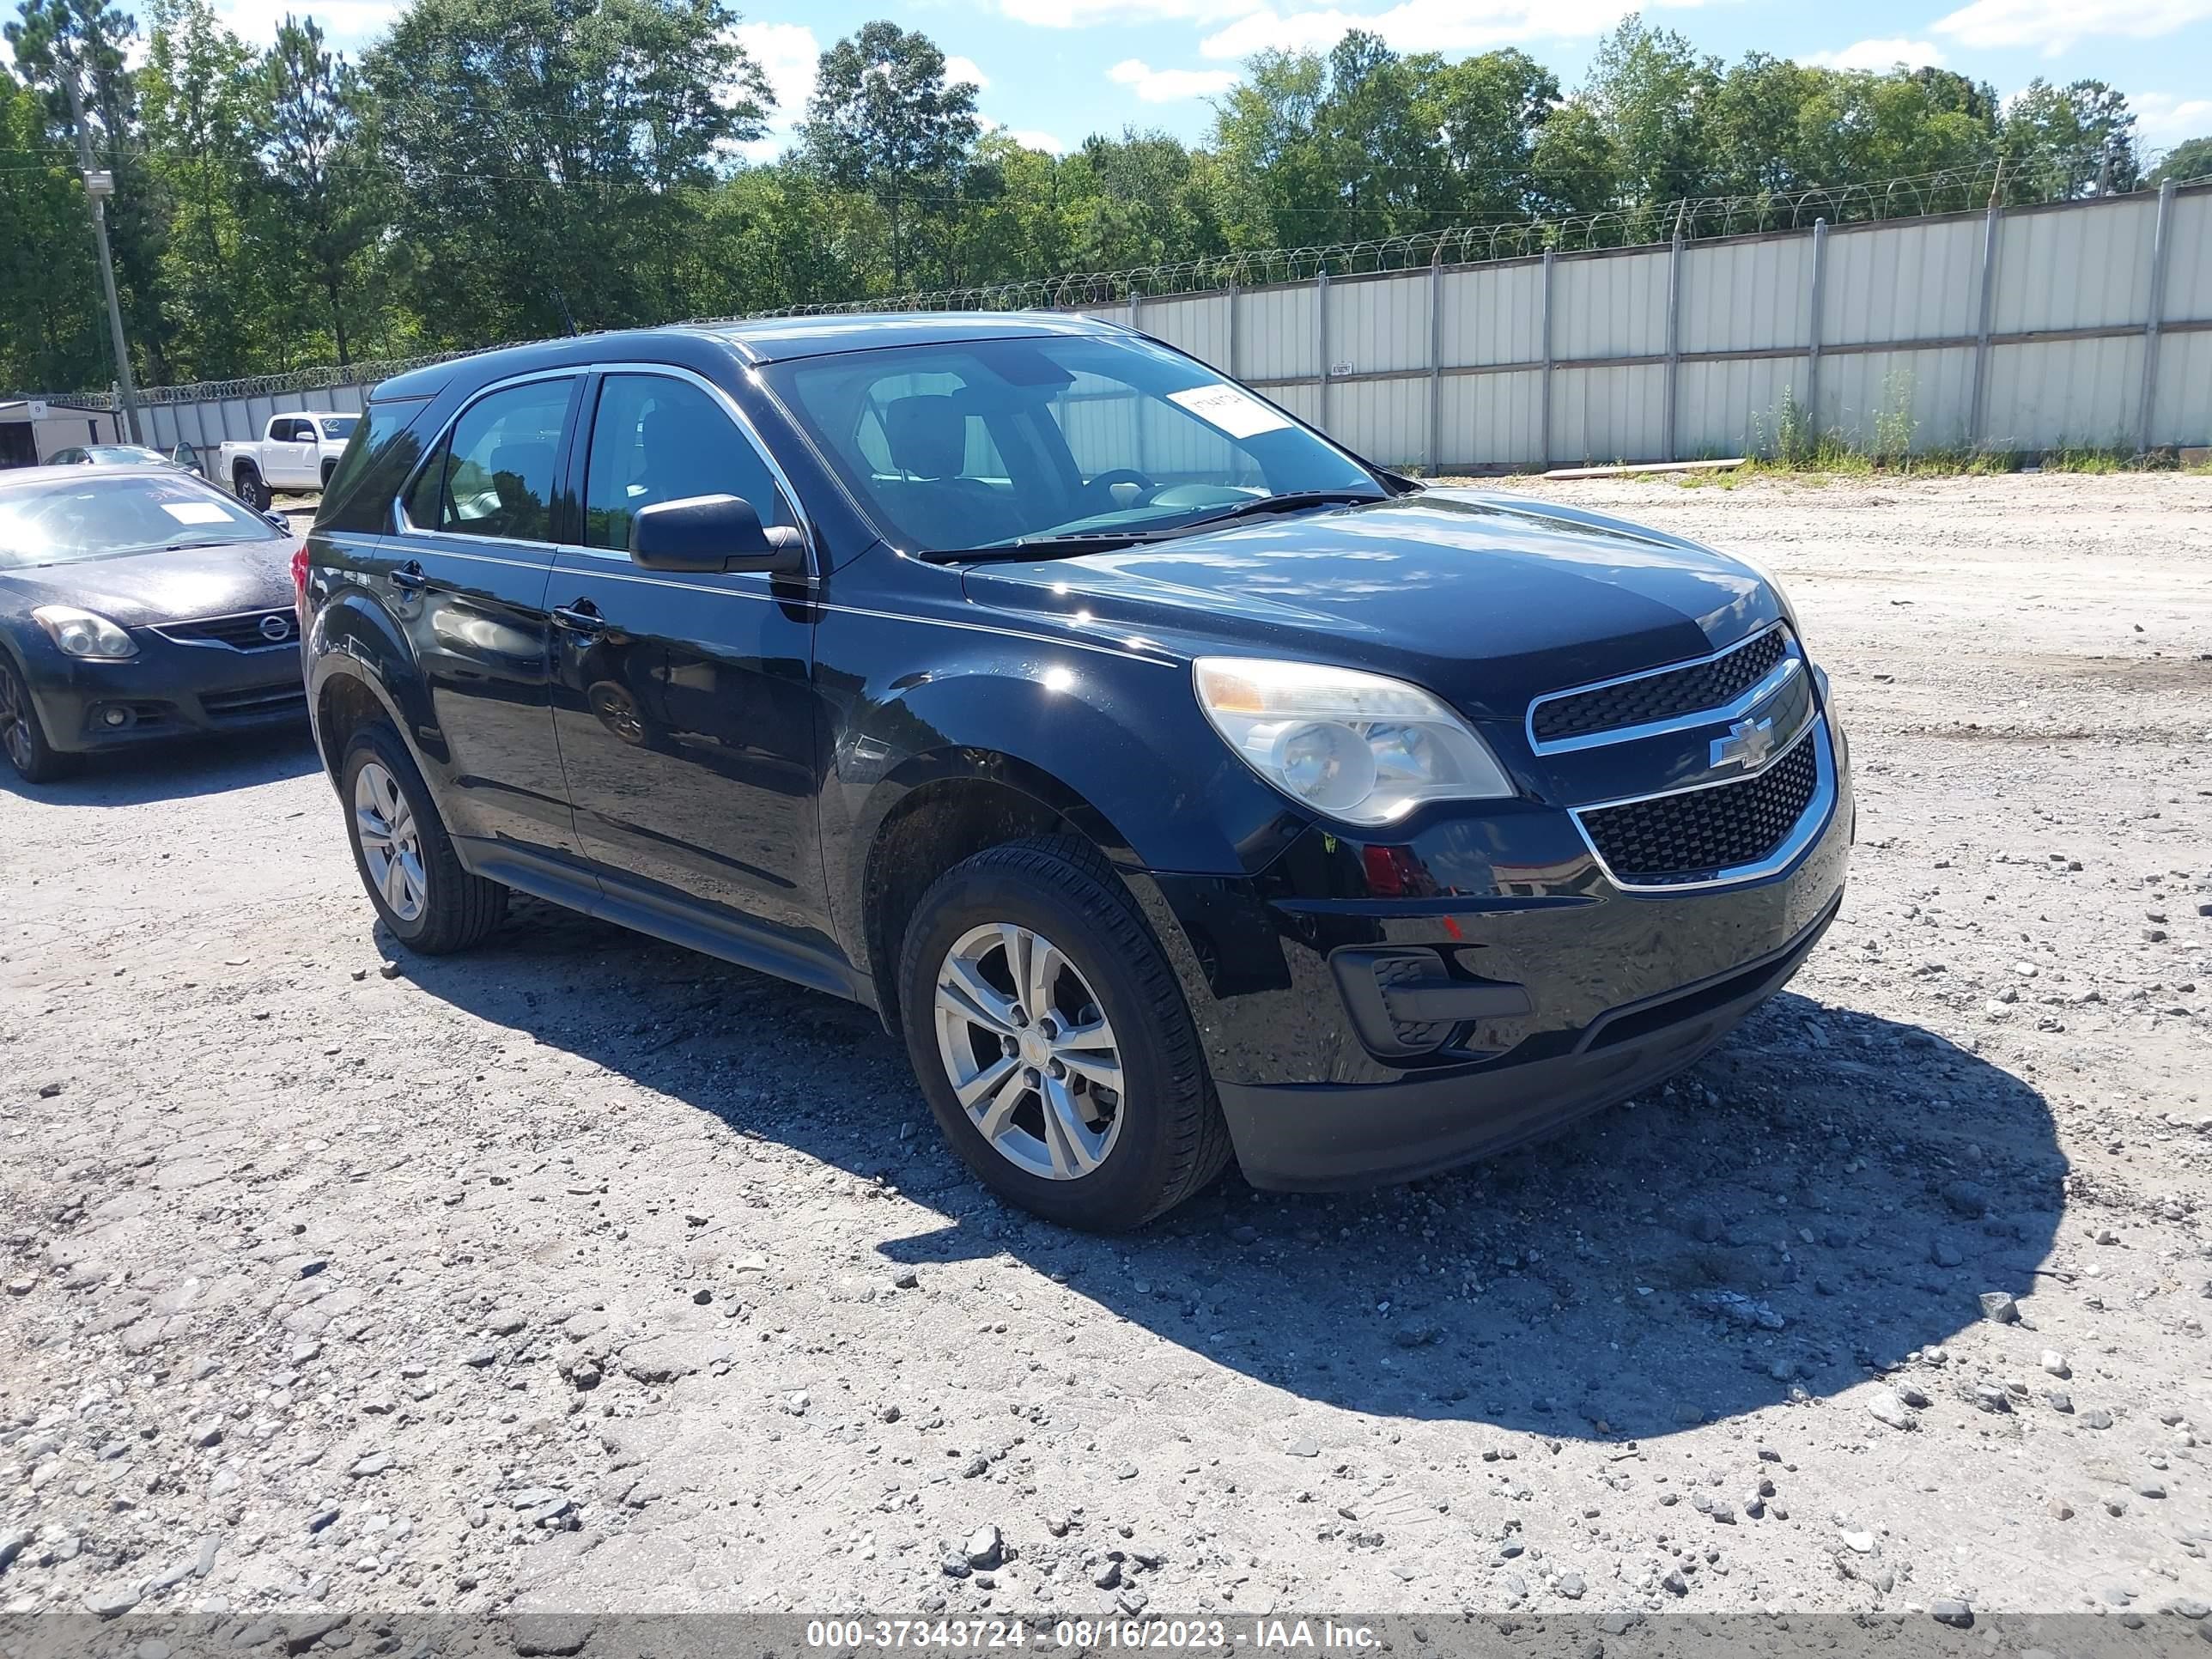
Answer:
[936,922,1121,1182]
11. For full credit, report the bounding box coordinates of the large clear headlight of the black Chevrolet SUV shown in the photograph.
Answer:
[1192,657,1513,827]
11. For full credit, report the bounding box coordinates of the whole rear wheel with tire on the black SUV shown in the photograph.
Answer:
[338,726,507,956]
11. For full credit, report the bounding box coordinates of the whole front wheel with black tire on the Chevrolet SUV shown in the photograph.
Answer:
[898,838,1230,1232]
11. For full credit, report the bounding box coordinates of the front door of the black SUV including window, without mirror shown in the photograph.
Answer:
[550,369,836,957]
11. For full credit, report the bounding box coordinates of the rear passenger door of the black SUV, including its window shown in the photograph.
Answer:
[393,372,581,863]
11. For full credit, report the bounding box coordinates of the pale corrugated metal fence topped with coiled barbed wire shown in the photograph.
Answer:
[116,184,2212,471]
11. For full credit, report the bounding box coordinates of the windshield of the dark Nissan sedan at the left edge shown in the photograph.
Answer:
[0,473,279,571]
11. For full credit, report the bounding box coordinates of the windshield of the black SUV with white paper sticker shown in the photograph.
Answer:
[768,334,1385,553]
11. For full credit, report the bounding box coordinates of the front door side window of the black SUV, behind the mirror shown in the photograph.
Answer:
[584,374,796,550]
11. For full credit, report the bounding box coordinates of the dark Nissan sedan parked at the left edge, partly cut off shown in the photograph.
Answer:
[0,467,305,783]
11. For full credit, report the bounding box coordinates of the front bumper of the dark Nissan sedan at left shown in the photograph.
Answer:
[27,629,307,754]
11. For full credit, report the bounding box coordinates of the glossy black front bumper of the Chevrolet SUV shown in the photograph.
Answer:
[1134,726,1856,1190]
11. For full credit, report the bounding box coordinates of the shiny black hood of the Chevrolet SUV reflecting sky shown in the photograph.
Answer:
[967,489,1783,721]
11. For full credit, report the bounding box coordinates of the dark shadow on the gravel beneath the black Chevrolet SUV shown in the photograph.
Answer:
[385,902,2066,1437]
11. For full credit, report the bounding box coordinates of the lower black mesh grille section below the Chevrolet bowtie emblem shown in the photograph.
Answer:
[1577,723,1820,887]
